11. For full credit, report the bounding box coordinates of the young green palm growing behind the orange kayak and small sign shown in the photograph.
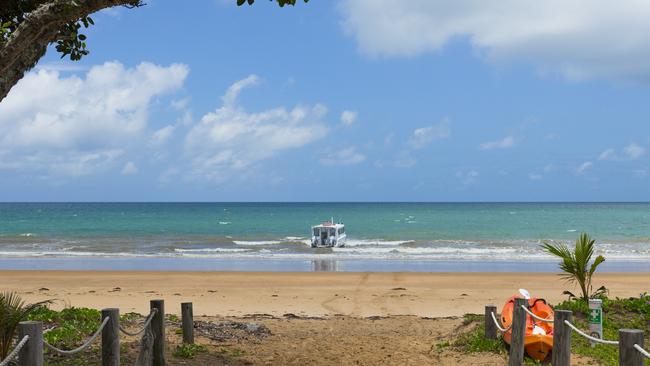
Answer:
[542,233,607,301]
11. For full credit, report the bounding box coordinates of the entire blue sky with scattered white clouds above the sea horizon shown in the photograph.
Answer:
[0,0,650,201]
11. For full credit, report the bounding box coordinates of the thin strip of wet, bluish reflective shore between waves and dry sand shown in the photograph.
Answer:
[0,256,650,273]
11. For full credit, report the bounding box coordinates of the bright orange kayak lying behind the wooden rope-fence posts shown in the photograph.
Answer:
[501,295,553,360]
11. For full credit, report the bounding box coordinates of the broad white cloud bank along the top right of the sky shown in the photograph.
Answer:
[340,0,650,79]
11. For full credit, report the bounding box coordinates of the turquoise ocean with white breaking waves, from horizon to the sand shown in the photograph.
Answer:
[0,203,650,271]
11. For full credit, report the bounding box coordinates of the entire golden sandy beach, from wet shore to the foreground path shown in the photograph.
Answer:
[0,271,650,365]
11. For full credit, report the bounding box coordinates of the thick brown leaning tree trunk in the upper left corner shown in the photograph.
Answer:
[0,0,138,102]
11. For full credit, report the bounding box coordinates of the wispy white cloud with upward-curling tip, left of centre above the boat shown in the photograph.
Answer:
[185,75,328,182]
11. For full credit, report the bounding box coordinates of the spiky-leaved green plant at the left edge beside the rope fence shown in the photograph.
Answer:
[0,292,49,360]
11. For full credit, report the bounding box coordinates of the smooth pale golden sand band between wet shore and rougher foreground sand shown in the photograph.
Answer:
[0,270,650,317]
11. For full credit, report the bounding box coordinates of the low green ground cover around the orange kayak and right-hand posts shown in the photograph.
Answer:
[448,294,650,365]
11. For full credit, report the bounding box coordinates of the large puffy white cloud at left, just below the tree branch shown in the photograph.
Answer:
[0,62,189,175]
